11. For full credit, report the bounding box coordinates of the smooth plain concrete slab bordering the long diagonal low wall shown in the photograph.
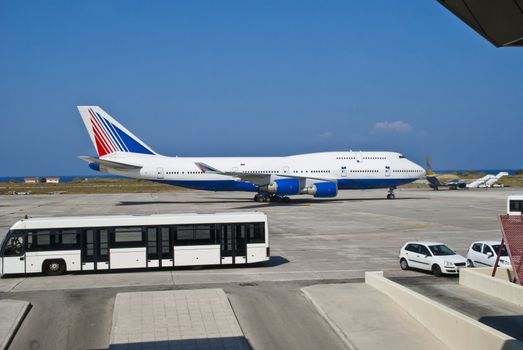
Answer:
[302,283,448,350]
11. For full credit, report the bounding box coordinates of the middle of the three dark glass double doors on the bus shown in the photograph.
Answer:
[147,227,174,267]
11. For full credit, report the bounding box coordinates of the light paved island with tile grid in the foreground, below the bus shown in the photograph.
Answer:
[109,289,250,350]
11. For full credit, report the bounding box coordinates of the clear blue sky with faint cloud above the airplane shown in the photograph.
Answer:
[0,0,523,176]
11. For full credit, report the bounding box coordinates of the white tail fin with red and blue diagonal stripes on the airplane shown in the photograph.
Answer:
[78,106,156,157]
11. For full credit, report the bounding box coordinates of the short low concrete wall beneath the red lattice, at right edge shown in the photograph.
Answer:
[459,268,523,307]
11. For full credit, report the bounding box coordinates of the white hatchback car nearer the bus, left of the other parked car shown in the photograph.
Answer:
[399,242,467,276]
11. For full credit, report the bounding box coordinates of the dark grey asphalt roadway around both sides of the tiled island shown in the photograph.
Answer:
[1,281,345,350]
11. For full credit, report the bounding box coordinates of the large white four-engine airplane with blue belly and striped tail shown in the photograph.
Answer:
[78,106,425,202]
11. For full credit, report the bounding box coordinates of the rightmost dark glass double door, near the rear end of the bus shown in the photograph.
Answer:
[219,224,247,264]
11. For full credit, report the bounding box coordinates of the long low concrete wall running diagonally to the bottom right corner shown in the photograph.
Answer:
[365,271,523,350]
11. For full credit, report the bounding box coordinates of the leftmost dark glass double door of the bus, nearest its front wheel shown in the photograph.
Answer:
[82,229,109,271]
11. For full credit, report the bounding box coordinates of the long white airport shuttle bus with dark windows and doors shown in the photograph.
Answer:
[0,212,269,275]
